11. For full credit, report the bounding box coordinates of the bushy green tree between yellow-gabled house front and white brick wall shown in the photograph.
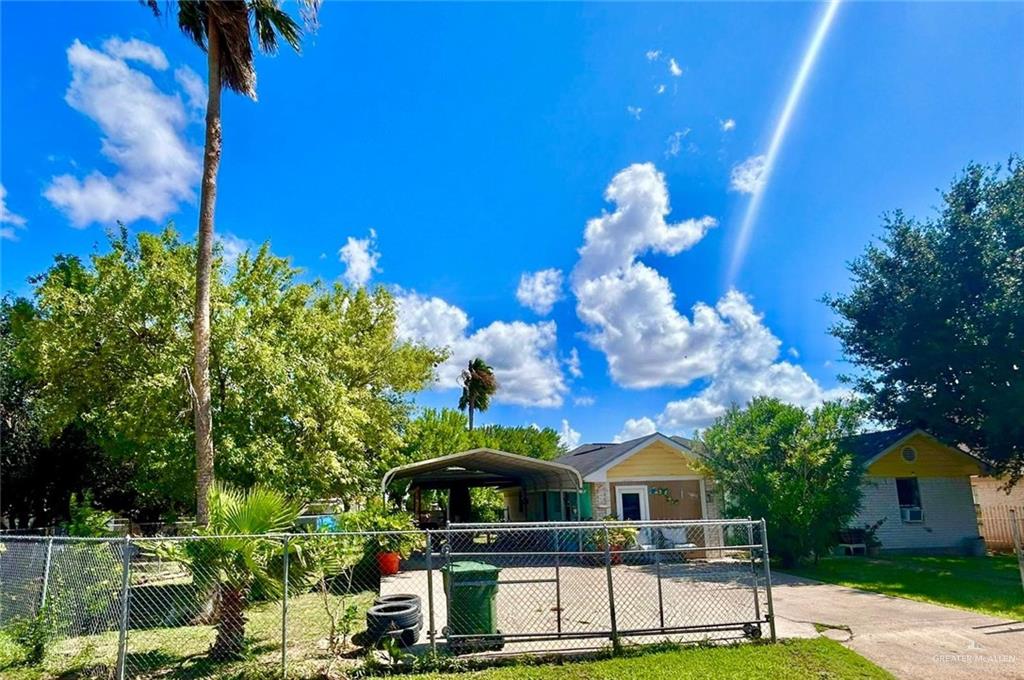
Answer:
[701,396,862,566]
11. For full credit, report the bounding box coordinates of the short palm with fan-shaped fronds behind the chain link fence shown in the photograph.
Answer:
[154,483,306,660]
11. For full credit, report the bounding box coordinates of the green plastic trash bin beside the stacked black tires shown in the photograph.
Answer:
[441,560,505,651]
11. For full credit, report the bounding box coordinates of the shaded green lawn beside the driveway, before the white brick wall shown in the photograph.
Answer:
[787,555,1024,621]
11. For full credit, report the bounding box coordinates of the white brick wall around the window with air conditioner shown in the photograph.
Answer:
[852,476,978,551]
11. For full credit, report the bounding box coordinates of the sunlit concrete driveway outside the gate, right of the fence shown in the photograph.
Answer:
[772,573,1024,680]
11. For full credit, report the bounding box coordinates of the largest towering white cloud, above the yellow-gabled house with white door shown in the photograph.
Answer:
[571,164,846,438]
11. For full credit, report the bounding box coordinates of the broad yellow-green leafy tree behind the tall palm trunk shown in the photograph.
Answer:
[15,229,444,510]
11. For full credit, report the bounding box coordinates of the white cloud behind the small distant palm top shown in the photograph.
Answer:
[395,291,568,408]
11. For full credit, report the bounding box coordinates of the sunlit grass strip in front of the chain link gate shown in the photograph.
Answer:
[401,638,893,680]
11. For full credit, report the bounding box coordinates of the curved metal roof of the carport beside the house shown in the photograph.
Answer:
[381,449,583,491]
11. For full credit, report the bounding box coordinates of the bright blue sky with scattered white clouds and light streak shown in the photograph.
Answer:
[0,2,1024,441]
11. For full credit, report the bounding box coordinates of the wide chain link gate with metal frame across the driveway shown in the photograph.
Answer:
[427,520,775,653]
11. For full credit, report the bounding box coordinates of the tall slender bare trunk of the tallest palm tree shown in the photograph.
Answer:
[193,16,221,524]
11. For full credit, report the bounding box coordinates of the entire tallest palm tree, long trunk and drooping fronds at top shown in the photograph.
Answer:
[143,0,319,524]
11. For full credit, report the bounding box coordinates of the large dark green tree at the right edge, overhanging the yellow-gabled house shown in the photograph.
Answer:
[825,158,1024,481]
